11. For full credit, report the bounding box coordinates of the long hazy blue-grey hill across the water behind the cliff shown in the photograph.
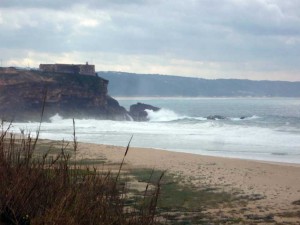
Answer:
[97,71,300,97]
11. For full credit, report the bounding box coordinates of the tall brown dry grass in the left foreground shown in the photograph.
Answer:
[0,122,161,225]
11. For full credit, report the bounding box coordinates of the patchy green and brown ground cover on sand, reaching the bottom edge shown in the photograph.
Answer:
[130,169,242,225]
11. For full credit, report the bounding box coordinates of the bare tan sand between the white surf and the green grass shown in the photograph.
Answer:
[77,143,300,224]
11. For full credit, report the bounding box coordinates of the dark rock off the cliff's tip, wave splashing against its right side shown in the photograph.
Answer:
[129,102,160,121]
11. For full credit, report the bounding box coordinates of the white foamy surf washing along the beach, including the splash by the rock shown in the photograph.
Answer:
[8,110,300,163]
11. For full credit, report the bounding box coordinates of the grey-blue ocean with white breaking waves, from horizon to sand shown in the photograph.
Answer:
[8,98,300,164]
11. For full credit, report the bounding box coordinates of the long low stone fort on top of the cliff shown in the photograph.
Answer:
[39,62,96,76]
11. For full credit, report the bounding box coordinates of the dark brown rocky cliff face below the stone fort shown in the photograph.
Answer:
[0,68,127,121]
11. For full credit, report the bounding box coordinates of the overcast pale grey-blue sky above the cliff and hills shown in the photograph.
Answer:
[0,0,300,81]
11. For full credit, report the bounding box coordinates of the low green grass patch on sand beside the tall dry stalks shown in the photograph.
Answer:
[130,169,237,212]
